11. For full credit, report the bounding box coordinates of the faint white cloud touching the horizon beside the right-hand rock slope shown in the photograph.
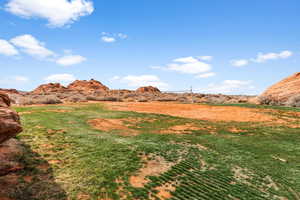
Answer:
[199,80,255,94]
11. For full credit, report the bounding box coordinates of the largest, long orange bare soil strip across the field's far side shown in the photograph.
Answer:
[105,102,277,122]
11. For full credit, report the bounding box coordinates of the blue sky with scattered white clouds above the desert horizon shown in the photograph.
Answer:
[0,0,300,94]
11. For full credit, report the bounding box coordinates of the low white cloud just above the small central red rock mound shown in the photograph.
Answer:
[111,75,169,89]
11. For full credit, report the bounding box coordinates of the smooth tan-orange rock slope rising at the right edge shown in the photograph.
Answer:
[260,72,300,103]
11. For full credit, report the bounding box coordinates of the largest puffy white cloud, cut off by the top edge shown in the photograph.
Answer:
[5,0,94,27]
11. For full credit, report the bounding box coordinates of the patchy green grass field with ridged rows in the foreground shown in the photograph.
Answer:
[11,104,300,200]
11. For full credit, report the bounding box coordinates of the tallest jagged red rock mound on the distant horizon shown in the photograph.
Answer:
[68,79,109,94]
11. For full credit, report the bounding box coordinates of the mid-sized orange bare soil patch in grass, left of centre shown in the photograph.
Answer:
[88,118,138,136]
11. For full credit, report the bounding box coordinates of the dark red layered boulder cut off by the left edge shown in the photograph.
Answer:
[0,93,22,144]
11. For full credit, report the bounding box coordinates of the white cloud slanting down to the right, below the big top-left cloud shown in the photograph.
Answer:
[10,34,55,58]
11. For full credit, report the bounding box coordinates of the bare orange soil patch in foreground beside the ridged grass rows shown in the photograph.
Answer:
[129,156,174,187]
